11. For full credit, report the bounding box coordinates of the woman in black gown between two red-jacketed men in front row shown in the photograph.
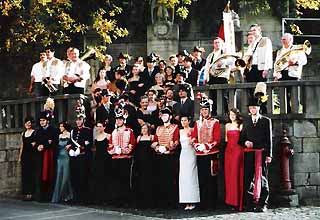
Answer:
[134,123,154,208]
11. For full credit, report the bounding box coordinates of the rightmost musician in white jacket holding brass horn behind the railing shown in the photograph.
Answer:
[273,33,311,112]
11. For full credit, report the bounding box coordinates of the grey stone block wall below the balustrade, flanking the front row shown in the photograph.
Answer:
[0,118,320,203]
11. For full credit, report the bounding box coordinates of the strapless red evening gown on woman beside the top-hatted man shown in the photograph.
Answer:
[224,130,243,206]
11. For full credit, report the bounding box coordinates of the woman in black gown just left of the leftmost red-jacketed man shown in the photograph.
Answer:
[93,121,112,204]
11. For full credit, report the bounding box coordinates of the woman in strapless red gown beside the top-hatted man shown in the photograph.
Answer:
[224,108,243,211]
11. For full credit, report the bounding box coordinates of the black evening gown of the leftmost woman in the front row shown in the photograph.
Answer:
[21,131,36,195]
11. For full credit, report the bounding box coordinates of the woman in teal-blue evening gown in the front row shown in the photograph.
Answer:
[51,122,73,203]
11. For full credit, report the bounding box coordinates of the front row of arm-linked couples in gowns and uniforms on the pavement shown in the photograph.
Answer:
[19,93,272,211]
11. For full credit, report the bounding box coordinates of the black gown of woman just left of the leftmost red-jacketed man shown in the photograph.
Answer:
[92,138,112,203]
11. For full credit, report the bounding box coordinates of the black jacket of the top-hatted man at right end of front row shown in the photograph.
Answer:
[238,115,272,157]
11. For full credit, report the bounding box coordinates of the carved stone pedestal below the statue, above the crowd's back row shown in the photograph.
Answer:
[147,23,179,61]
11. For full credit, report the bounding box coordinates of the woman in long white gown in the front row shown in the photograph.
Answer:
[179,116,200,210]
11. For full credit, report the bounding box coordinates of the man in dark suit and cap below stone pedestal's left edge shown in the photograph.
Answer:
[140,56,160,92]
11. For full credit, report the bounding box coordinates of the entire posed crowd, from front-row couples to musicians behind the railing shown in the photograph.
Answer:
[19,25,306,211]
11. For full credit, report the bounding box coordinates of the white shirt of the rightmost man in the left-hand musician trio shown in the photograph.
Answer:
[65,59,90,88]
